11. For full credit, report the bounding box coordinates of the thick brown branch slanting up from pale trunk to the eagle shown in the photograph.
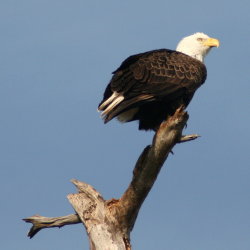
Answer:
[117,108,188,231]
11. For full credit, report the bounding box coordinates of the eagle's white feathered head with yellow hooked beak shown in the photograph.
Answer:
[176,32,220,62]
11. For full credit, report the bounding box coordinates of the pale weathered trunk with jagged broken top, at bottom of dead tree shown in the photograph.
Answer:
[68,180,130,250]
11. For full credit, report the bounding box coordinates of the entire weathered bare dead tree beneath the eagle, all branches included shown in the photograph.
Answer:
[24,107,198,250]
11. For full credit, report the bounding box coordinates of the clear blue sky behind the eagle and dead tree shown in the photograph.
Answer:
[0,0,250,250]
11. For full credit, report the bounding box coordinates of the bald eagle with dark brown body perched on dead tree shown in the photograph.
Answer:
[98,33,219,130]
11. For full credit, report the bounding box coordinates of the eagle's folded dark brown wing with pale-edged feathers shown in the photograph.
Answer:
[99,49,206,122]
